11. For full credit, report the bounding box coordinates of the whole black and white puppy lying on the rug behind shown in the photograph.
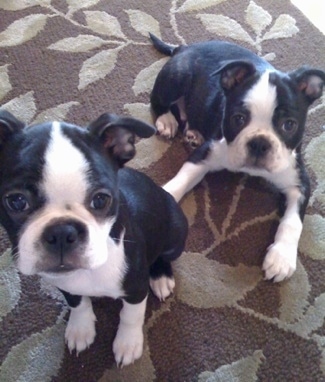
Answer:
[151,35,325,281]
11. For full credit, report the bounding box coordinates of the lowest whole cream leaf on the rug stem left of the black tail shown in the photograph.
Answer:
[78,49,118,90]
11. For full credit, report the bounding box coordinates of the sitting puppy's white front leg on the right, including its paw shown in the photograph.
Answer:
[113,296,147,367]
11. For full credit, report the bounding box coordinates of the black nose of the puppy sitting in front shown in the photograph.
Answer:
[42,221,87,256]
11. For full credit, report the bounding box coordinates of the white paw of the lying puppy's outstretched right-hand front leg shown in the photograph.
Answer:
[263,242,297,282]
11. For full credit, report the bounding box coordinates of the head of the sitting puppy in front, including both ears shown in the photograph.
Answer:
[0,111,155,275]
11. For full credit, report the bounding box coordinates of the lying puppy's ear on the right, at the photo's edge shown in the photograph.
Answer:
[289,66,325,105]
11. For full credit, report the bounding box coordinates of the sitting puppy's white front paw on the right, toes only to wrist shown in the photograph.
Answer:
[113,323,143,367]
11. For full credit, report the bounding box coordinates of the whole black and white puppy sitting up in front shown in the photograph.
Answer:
[0,110,187,366]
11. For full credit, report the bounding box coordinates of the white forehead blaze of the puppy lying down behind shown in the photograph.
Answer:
[245,72,277,123]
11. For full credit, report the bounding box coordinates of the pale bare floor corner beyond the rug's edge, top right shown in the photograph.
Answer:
[291,0,325,35]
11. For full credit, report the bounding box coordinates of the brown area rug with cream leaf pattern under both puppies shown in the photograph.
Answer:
[0,0,325,382]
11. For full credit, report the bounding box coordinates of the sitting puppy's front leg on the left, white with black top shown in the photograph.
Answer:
[62,291,96,354]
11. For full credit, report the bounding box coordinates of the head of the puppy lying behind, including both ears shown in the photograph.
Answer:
[215,61,325,173]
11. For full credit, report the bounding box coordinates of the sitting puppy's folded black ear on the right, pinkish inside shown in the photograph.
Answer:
[88,113,156,166]
